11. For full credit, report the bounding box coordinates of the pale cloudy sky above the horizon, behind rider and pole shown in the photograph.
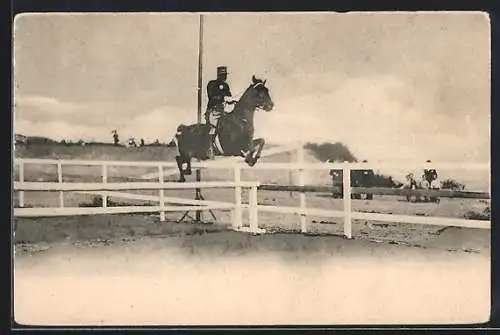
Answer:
[14,12,490,162]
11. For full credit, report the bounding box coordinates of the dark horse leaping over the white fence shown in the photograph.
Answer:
[175,75,274,182]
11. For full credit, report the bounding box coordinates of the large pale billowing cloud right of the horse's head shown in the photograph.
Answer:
[255,75,489,161]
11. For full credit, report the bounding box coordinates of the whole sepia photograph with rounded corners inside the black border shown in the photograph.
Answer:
[11,11,491,327]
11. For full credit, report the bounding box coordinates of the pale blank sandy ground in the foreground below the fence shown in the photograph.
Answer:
[14,232,490,325]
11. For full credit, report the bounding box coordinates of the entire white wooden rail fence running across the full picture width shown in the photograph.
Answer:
[14,146,491,238]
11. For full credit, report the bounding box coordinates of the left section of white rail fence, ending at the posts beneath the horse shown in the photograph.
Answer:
[14,159,265,233]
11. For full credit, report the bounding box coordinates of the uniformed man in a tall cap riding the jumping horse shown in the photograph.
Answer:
[205,66,236,157]
